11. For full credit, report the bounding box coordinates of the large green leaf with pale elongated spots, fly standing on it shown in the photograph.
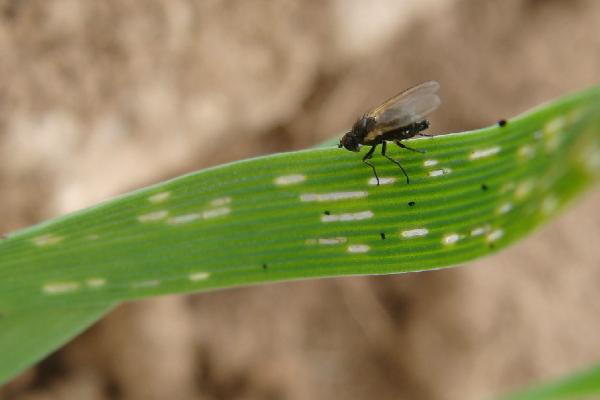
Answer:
[0,83,600,380]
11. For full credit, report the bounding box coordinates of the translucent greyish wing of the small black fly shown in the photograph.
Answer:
[367,81,440,135]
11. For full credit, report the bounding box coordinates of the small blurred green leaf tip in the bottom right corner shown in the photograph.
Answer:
[503,365,600,400]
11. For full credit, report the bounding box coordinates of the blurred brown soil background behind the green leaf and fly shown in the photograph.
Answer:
[0,0,600,400]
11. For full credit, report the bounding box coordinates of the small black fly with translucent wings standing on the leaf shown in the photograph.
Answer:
[338,81,440,186]
